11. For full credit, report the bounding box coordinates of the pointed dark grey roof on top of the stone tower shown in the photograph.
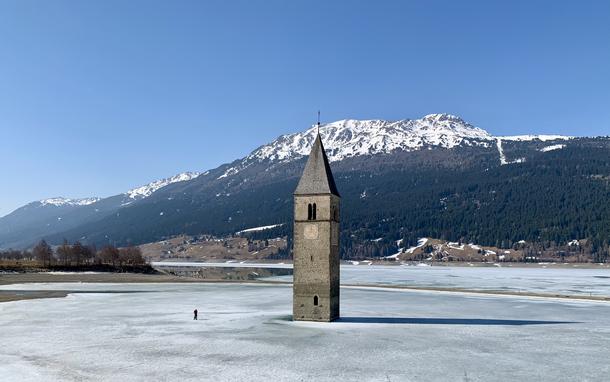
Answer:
[294,134,340,196]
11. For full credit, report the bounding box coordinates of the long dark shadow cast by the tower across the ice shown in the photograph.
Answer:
[335,317,578,326]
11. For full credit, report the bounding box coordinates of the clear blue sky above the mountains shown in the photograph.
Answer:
[0,0,610,216]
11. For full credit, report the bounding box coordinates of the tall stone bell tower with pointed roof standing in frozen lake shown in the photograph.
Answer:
[292,133,340,321]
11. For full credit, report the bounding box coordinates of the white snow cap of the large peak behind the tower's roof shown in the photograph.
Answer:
[219,114,572,179]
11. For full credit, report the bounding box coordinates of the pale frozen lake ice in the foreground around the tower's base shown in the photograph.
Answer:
[0,283,610,382]
